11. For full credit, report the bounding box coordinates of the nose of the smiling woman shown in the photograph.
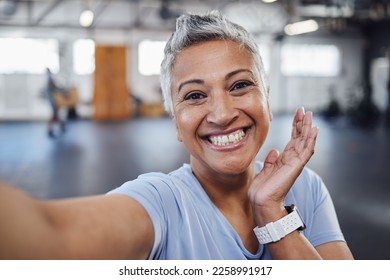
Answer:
[206,91,239,126]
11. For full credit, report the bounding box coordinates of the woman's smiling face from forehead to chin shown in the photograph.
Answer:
[172,40,271,175]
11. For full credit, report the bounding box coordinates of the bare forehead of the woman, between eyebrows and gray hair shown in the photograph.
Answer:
[172,40,254,84]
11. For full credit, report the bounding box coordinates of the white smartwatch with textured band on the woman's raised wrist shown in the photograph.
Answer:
[253,204,306,244]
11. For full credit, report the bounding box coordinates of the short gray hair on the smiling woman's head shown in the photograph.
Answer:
[160,11,268,114]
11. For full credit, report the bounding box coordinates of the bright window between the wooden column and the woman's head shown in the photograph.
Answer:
[138,40,166,76]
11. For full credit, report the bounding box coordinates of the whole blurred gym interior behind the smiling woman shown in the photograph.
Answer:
[0,0,390,259]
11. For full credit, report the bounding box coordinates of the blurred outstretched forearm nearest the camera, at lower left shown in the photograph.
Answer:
[0,183,61,259]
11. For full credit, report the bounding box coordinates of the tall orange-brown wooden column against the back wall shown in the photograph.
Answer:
[93,45,131,120]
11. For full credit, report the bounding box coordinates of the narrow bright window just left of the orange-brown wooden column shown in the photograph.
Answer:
[73,39,95,75]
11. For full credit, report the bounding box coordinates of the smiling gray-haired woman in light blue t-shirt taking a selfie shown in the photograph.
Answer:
[0,12,352,259]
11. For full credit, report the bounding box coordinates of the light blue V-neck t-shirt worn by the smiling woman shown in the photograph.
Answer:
[109,162,344,260]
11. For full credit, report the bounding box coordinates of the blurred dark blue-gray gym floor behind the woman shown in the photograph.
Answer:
[0,115,390,260]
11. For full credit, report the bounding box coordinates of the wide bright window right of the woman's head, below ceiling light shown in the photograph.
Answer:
[281,44,341,77]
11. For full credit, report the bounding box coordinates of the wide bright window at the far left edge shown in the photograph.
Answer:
[0,38,60,74]
